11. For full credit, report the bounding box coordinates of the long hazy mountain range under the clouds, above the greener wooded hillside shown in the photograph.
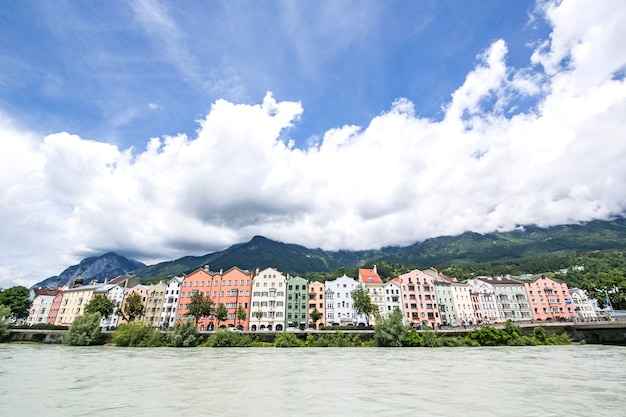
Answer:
[35,217,626,287]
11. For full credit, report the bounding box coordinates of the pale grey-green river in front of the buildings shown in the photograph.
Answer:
[0,344,626,417]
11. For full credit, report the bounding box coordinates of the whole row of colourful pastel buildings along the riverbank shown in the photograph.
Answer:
[27,266,598,331]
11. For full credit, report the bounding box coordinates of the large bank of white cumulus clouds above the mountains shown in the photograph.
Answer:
[0,1,626,282]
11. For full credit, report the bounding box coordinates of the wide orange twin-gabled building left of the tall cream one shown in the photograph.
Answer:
[177,266,254,331]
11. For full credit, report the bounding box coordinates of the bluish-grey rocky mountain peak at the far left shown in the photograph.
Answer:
[33,252,145,289]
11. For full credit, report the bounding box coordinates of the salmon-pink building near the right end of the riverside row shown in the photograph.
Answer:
[522,275,576,321]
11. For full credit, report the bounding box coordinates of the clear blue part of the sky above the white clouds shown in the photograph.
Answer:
[0,1,547,150]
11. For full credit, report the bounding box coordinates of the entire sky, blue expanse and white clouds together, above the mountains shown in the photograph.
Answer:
[0,0,626,288]
